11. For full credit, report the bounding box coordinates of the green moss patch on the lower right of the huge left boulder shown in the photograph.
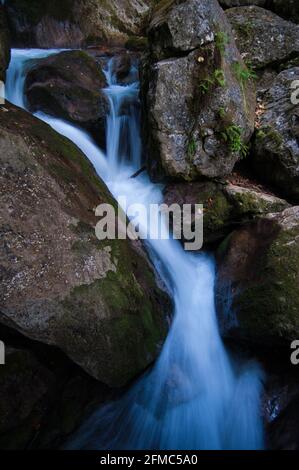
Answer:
[61,227,168,386]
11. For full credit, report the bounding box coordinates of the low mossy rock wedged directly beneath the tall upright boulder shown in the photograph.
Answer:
[164,181,288,245]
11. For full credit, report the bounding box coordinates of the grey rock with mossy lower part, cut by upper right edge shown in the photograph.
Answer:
[253,67,299,202]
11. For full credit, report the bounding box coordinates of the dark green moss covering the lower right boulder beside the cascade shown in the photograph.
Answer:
[236,228,299,340]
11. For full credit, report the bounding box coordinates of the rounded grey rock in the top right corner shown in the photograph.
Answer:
[226,6,299,68]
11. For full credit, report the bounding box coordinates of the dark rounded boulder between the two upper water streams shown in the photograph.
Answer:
[25,51,109,147]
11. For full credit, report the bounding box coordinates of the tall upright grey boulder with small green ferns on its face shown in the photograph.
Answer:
[142,0,255,180]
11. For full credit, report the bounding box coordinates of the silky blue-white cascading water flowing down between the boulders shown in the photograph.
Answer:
[6,50,263,450]
